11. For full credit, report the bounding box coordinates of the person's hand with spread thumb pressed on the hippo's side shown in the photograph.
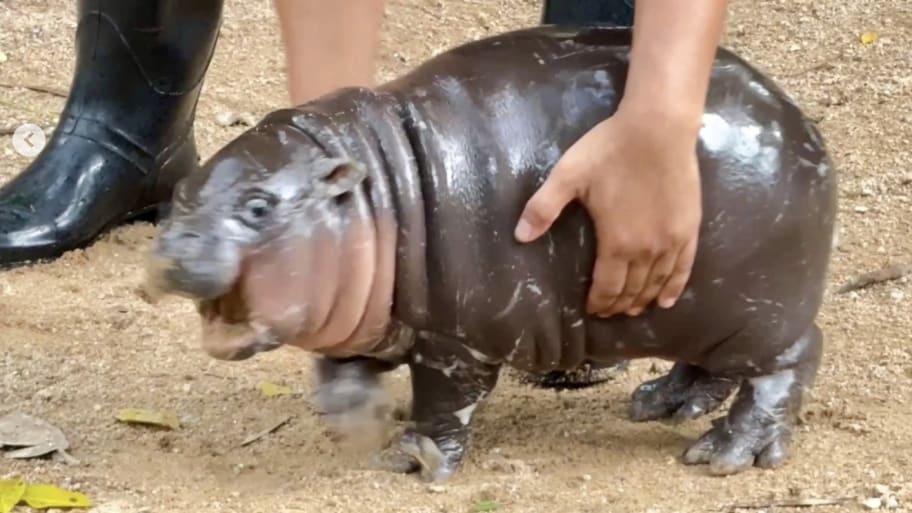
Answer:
[515,104,702,317]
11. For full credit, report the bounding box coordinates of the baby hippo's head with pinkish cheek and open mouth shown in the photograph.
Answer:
[146,111,391,360]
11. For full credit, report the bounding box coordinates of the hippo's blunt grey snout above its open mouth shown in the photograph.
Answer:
[146,220,240,300]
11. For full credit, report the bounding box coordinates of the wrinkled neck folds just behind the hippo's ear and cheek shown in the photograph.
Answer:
[291,88,428,354]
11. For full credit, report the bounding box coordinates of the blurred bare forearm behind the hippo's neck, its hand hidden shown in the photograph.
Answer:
[275,0,385,105]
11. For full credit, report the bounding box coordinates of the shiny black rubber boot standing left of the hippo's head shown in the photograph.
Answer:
[0,0,223,267]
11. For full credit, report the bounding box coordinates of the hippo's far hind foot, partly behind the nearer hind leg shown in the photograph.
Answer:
[630,363,738,423]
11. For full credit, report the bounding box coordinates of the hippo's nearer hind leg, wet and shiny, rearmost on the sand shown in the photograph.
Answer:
[684,324,823,475]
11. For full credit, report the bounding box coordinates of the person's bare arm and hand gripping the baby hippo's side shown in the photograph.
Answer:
[516,0,726,316]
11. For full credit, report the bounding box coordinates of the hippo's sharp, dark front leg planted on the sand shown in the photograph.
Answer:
[382,335,500,482]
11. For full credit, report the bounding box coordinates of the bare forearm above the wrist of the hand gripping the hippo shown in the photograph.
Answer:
[620,0,727,135]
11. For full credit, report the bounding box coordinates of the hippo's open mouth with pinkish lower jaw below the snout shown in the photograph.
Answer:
[198,289,282,361]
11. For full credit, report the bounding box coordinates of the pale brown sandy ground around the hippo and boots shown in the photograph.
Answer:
[0,0,912,513]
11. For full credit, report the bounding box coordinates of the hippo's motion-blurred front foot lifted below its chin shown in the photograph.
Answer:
[314,357,395,443]
